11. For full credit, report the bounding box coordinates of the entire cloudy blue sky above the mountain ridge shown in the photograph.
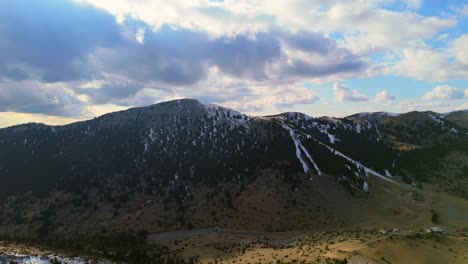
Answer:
[0,0,468,127]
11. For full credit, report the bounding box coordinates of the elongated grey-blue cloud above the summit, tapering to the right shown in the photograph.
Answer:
[97,26,371,85]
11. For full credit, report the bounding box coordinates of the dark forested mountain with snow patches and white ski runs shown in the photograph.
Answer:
[0,99,468,237]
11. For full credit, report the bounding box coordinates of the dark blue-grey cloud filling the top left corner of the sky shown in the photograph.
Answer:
[0,0,121,82]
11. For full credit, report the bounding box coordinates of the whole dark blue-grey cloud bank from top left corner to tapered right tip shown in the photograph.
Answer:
[0,0,369,85]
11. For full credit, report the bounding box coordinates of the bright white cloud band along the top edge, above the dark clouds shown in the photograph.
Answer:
[76,0,456,53]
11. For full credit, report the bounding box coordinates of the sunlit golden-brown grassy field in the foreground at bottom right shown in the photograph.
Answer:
[153,231,468,264]
